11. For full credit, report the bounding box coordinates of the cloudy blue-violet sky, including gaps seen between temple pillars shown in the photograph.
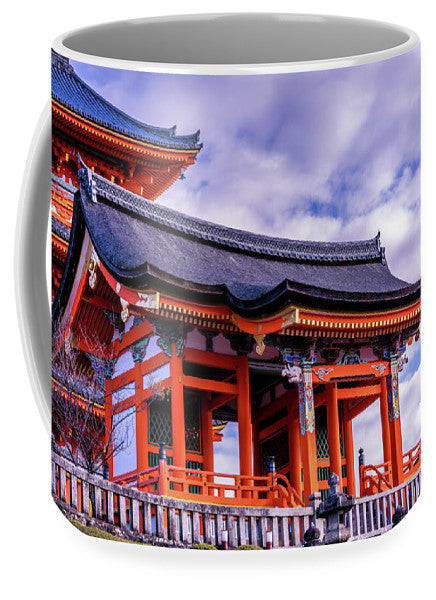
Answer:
[73,49,420,488]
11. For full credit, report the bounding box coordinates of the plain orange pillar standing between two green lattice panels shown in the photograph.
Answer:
[170,342,186,468]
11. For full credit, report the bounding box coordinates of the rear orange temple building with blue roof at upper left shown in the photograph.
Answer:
[52,51,201,298]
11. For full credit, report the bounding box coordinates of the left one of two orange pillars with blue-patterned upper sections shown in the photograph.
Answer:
[298,363,318,505]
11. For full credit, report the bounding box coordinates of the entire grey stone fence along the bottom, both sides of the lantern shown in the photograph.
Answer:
[52,454,421,548]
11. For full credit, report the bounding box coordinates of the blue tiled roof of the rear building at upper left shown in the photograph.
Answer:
[51,50,202,150]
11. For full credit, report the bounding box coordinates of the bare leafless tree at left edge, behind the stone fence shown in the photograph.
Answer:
[52,316,147,473]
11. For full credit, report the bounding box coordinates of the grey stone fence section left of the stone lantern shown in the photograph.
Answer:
[52,455,314,548]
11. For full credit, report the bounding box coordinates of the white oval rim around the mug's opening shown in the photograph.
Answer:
[52,12,420,75]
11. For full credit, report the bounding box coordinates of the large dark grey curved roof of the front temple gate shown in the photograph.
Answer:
[53,162,420,318]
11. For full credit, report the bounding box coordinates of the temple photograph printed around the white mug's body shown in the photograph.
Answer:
[43,14,421,550]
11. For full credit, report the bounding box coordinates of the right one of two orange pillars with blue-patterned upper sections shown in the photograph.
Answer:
[386,354,404,486]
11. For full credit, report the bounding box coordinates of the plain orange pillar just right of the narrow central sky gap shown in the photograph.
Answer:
[236,356,253,477]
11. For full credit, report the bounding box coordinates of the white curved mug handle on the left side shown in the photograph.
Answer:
[14,102,51,432]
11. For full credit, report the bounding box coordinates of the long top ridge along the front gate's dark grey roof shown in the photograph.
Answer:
[79,165,384,263]
